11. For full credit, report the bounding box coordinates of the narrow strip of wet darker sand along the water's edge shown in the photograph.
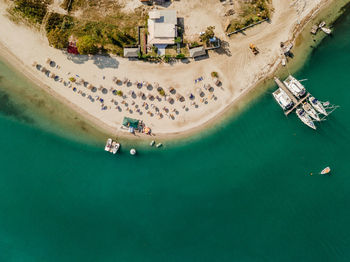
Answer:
[0,1,345,143]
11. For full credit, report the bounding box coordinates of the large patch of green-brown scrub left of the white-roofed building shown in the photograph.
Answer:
[10,0,146,56]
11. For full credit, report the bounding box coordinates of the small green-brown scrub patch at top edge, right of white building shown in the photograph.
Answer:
[226,0,272,32]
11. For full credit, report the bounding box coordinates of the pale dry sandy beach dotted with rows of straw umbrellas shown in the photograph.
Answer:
[0,0,332,138]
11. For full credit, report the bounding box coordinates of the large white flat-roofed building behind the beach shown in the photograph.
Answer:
[147,9,177,55]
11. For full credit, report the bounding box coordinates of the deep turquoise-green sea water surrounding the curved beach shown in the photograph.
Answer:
[0,9,350,262]
